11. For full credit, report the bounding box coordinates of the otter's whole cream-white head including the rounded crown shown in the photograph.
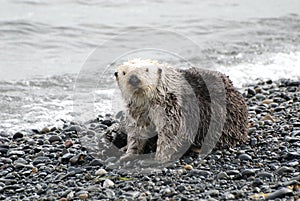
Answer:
[114,59,162,103]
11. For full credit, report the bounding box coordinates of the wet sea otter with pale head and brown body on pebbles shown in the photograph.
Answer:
[115,59,248,162]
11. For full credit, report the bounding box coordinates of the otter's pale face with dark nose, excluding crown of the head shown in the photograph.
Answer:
[114,65,159,101]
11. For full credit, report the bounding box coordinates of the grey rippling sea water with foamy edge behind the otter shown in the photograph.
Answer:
[0,0,300,133]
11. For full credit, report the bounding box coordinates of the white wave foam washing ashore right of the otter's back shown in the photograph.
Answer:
[216,52,300,88]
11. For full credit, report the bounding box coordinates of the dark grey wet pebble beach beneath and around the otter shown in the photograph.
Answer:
[0,80,300,201]
